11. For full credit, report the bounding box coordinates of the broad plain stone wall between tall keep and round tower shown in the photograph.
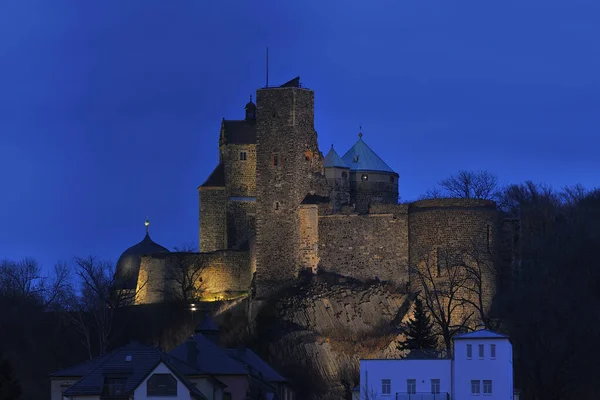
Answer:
[319,205,409,285]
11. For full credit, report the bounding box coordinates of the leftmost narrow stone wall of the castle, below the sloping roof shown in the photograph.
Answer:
[198,187,227,252]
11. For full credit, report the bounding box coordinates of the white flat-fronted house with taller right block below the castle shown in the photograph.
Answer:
[360,329,518,400]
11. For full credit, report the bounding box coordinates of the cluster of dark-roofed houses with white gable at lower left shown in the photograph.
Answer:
[50,316,295,400]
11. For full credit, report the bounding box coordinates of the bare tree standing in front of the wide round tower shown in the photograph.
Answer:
[411,248,474,354]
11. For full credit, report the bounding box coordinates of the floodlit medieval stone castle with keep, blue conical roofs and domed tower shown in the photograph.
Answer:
[116,78,499,304]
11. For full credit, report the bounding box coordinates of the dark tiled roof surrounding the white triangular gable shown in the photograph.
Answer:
[58,343,206,400]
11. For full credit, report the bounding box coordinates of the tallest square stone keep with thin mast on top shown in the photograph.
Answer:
[255,78,328,298]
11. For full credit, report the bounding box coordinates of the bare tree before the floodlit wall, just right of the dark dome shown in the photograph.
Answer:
[165,246,206,304]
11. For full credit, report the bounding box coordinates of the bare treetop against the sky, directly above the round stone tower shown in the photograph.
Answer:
[435,170,500,200]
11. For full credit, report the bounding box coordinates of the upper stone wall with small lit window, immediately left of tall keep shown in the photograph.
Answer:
[223,144,256,197]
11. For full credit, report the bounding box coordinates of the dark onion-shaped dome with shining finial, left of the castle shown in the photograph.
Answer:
[115,220,169,290]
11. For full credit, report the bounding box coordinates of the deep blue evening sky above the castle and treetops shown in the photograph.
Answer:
[0,0,600,267]
